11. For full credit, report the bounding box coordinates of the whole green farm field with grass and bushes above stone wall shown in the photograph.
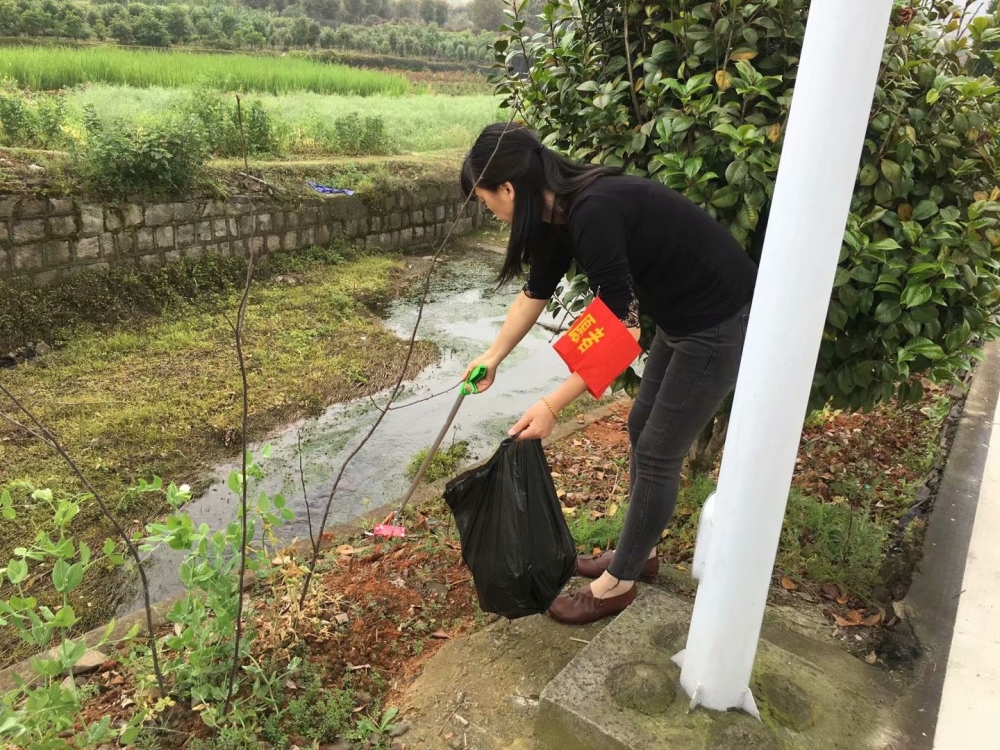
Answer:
[0,46,500,194]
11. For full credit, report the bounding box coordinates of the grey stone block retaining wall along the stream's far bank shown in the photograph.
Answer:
[0,184,482,285]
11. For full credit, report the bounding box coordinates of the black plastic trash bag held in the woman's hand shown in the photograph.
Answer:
[444,440,576,620]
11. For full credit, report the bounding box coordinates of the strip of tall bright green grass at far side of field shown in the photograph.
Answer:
[0,47,410,96]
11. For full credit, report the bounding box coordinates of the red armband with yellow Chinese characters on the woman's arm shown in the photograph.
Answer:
[555,299,642,398]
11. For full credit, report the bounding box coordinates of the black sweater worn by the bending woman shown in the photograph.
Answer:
[524,177,757,336]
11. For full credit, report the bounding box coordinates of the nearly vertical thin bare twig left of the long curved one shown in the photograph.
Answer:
[222,94,257,716]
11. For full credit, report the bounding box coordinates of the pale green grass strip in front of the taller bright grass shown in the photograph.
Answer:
[68,84,501,154]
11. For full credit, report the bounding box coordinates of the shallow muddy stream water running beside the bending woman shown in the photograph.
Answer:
[119,249,566,614]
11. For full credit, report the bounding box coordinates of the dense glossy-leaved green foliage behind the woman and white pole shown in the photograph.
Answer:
[497,0,1000,408]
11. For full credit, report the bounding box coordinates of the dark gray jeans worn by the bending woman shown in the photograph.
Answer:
[608,304,750,581]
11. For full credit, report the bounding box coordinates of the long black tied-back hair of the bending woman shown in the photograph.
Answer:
[462,123,621,284]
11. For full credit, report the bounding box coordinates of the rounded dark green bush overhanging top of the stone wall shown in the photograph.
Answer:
[79,117,208,196]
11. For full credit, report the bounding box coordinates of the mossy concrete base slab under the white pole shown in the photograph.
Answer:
[535,587,899,750]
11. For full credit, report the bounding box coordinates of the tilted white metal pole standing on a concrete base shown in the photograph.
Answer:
[674,0,892,715]
